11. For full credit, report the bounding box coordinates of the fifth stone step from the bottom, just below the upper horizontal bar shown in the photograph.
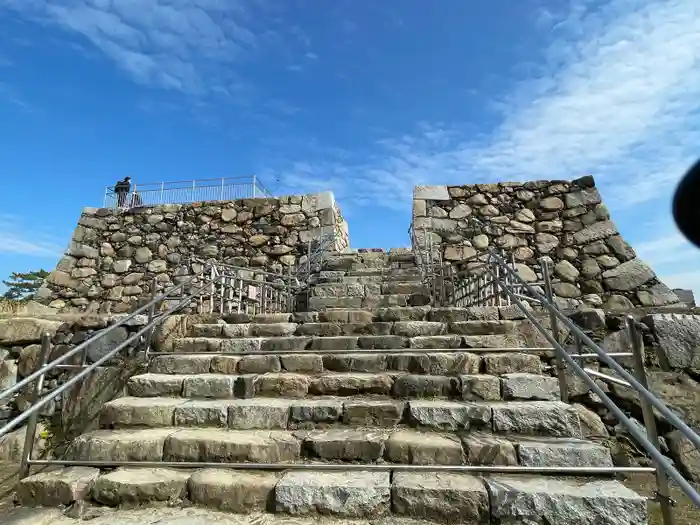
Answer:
[149,349,543,376]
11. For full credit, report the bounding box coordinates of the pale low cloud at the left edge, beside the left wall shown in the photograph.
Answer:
[0,214,65,259]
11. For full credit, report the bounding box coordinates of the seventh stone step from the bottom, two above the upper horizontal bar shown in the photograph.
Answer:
[189,316,522,338]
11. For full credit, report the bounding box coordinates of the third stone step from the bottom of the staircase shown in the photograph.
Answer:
[100,392,582,438]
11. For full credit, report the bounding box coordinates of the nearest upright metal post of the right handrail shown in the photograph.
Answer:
[625,315,676,525]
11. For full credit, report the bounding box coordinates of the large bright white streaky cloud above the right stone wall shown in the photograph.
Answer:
[268,0,700,213]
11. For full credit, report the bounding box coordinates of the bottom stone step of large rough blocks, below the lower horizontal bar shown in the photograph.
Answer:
[16,467,648,525]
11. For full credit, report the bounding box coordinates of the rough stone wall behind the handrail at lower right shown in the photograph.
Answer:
[569,309,700,483]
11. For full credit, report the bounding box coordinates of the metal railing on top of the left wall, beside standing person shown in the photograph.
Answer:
[103,175,272,209]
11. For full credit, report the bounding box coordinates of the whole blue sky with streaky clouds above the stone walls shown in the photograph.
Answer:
[0,0,700,292]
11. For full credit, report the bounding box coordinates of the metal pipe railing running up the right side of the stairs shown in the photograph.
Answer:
[414,233,700,525]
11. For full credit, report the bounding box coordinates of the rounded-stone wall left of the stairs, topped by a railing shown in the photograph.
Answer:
[36,192,349,313]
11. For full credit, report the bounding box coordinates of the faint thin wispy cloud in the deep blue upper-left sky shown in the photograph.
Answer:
[0,0,264,95]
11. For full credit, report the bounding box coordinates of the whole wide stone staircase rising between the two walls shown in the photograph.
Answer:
[18,248,647,525]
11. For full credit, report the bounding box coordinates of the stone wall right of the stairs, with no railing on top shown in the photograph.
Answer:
[412,176,678,308]
